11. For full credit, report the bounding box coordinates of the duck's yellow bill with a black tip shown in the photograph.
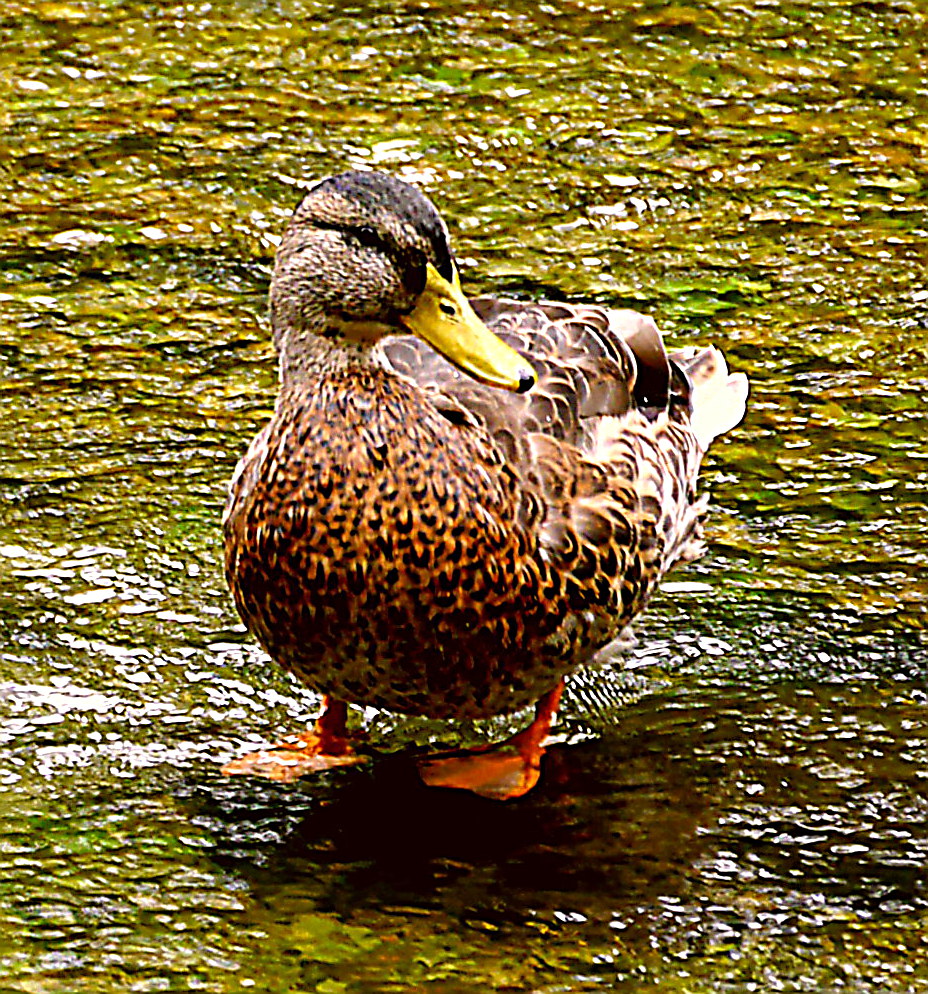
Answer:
[403,263,535,393]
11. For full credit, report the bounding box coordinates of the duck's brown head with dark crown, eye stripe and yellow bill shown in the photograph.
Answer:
[270,172,535,393]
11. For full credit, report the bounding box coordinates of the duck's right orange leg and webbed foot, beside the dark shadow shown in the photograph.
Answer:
[419,680,564,801]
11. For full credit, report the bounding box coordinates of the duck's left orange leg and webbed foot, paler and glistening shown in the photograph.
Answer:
[222,696,364,783]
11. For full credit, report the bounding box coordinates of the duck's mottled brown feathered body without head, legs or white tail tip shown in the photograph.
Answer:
[224,169,743,717]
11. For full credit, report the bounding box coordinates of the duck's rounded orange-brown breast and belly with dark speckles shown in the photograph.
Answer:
[225,370,568,716]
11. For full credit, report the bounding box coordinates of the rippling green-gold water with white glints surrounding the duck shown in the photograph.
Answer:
[0,0,928,994]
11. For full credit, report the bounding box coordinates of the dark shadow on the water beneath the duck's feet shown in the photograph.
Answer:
[188,704,711,908]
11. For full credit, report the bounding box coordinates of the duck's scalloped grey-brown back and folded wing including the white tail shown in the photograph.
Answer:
[383,290,747,620]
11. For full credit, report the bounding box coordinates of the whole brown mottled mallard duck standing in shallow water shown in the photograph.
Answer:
[224,171,747,798]
